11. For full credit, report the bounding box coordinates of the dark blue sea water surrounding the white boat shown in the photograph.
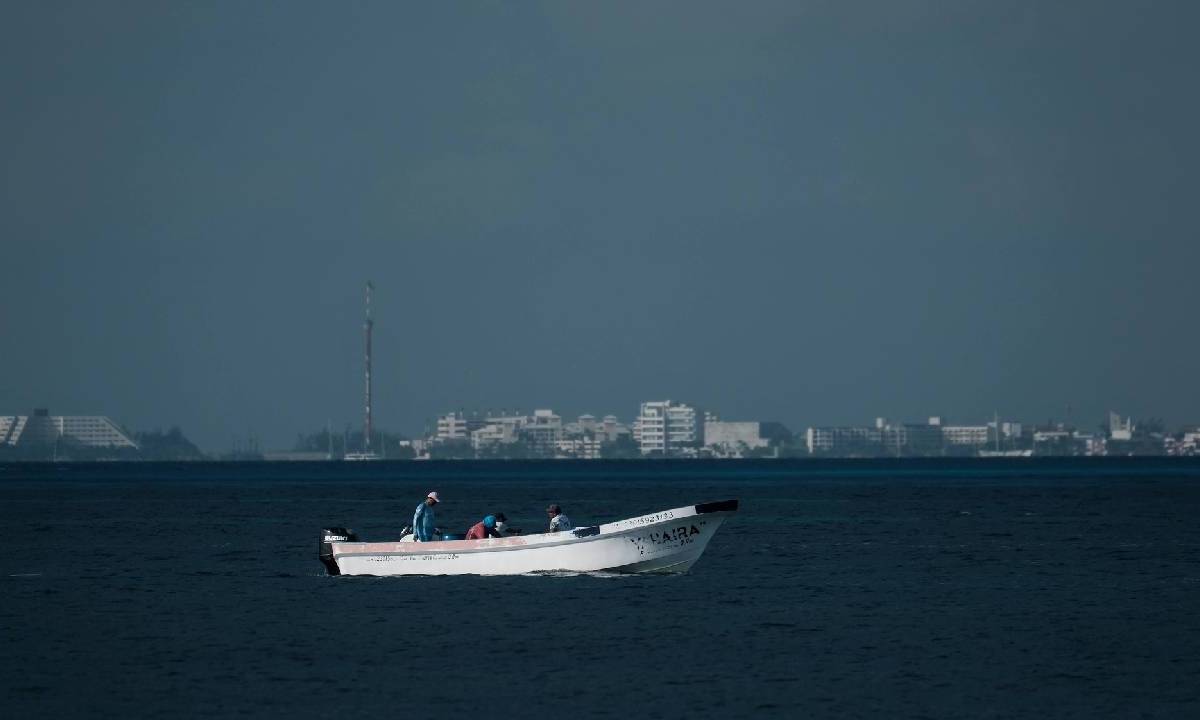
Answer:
[0,460,1200,720]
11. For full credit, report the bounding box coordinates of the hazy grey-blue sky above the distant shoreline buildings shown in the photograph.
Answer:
[0,0,1200,450]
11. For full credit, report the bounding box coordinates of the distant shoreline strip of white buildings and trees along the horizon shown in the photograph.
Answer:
[0,400,1200,460]
